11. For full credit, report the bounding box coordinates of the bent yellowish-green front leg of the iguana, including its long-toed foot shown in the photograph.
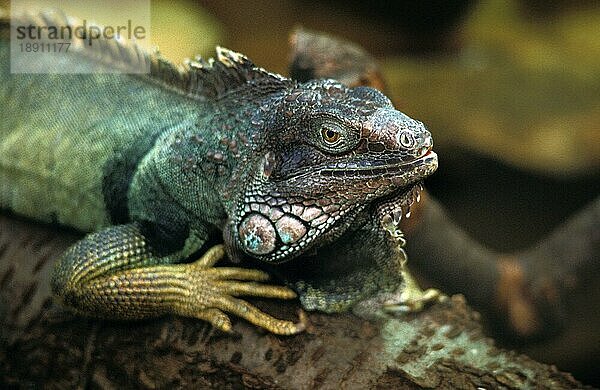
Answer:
[52,224,304,335]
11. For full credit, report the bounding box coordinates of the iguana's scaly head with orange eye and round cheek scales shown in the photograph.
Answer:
[225,80,437,263]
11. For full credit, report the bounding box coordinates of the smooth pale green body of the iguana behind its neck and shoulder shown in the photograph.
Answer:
[0,17,201,231]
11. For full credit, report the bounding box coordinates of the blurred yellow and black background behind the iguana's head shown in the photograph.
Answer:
[0,0,600,385]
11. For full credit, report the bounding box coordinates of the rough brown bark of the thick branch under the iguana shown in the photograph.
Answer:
[0,216,582,388]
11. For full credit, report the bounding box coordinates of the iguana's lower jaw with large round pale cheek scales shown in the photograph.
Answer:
[225,150,437,263]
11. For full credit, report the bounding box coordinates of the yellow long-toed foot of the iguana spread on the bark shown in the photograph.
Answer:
[173,245,306,335]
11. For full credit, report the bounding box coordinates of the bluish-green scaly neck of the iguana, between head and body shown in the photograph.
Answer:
[128,90,282,235]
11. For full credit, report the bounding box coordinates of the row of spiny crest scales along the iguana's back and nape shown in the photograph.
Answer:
[0,9,294,100]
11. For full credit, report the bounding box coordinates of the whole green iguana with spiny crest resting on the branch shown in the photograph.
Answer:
[0,13,437,334]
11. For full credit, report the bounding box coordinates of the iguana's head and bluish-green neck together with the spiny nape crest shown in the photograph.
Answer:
[139,47,437,263]
